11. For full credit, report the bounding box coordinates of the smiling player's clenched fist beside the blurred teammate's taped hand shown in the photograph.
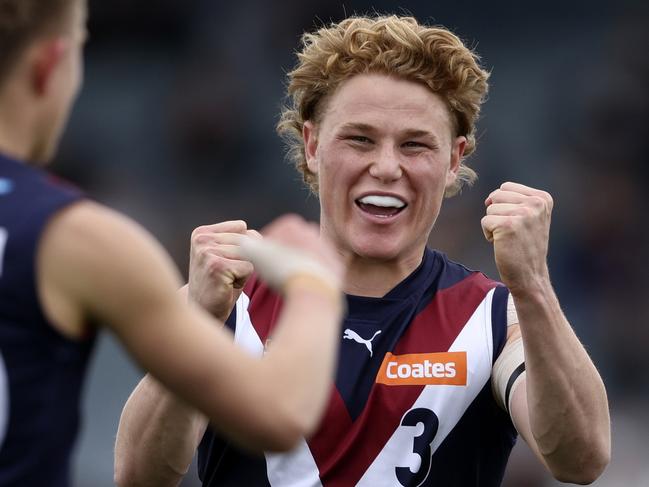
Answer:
[188,220,261,321]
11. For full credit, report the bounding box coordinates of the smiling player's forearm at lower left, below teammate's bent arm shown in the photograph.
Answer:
[115,375,207,487]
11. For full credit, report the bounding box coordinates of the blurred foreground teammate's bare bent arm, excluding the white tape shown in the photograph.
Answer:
[39,202,342,468]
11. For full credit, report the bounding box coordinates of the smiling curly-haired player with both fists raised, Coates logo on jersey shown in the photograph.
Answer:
[116,16,610,487]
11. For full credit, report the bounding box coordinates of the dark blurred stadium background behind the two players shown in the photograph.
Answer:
[54,0,649,487]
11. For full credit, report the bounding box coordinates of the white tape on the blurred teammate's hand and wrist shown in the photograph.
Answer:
[238,236,340,291]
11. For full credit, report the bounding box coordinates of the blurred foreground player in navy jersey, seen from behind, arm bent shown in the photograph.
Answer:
[0,0,350,487]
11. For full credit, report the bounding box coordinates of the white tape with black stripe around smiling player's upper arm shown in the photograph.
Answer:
[491,337,525,412]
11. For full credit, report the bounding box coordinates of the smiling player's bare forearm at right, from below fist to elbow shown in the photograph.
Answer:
[512,280,610,481]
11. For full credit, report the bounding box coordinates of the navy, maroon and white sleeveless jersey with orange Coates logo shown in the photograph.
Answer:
[198,249,516,487]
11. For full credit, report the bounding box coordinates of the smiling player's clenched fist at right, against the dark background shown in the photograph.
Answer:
[481,182,553,296]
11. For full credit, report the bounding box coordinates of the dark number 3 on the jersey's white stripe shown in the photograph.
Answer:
[395,408,439,486]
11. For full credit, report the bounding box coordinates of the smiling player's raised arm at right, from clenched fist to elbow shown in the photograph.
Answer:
[482,183,610,483]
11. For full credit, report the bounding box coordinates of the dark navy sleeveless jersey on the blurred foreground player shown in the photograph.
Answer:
[0,155,94,487]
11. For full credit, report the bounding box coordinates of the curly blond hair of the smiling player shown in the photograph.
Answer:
[277,15,489,196]
